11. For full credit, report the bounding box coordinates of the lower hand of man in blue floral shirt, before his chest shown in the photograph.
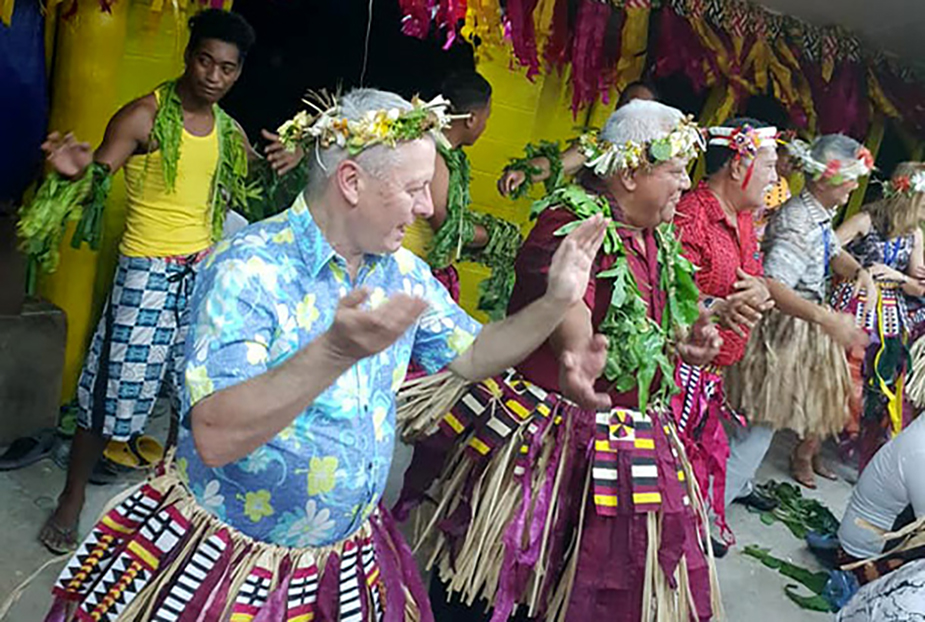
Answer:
[323,288,427,363]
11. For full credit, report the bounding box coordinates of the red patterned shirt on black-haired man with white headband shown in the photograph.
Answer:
[675,183,764,366]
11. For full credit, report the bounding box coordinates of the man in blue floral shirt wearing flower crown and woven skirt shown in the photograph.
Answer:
[43,89,606,622]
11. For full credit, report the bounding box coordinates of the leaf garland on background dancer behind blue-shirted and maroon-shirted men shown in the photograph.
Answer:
[427,143,522,320]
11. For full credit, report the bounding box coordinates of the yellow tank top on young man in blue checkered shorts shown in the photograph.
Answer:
[119,116,218,257]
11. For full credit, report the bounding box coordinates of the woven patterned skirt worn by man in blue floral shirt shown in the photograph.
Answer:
[45,473,433,622]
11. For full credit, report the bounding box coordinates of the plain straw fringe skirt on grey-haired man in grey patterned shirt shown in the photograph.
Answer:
[725,311,852,437]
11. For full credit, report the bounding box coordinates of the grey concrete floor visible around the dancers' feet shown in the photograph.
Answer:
[0,434,851,622]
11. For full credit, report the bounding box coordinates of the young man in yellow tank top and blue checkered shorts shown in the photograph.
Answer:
[20,10,301,553]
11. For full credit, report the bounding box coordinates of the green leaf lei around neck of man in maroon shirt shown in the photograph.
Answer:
[530,184,699,412]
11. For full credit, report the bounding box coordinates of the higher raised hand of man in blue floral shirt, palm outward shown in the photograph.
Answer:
[546,214,608,307]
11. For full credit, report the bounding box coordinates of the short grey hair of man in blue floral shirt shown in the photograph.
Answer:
[305,88,432,199]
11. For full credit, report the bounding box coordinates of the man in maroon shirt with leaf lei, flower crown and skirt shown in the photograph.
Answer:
[395,101,722,622]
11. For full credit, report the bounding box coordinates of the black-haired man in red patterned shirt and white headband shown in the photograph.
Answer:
[673,119,777,555]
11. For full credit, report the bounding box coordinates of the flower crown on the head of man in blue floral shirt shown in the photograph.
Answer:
[277,92,467,155]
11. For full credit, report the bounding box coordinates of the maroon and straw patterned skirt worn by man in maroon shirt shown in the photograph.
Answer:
[395,371,721,622]
